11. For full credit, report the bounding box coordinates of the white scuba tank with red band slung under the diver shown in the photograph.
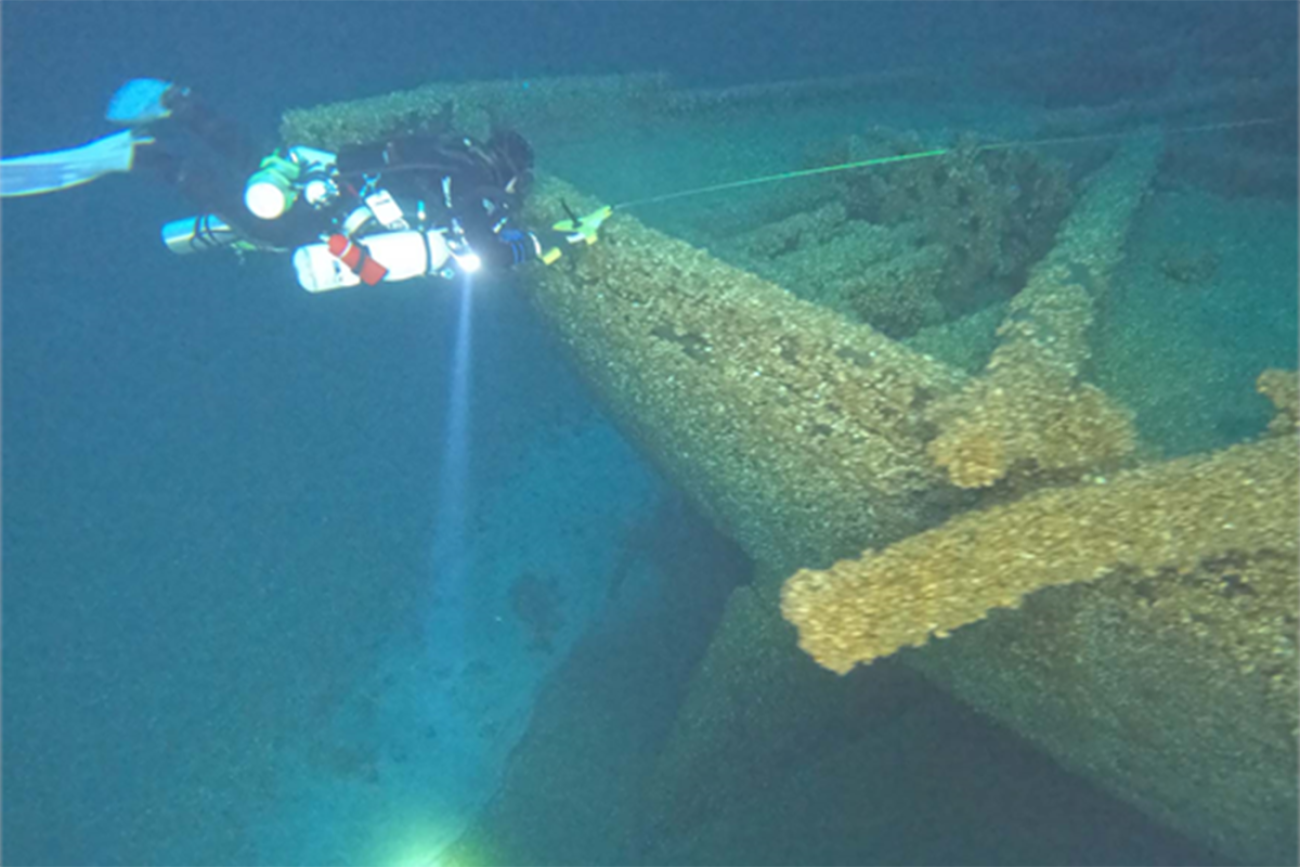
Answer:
[294,230,451,292]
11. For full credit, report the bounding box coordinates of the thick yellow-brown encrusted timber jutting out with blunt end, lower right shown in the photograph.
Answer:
[781,437,1300,673]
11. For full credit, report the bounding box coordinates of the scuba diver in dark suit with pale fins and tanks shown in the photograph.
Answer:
[0,78,610,292]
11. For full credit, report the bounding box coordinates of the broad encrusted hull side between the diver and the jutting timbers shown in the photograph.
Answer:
[527,175,965,569]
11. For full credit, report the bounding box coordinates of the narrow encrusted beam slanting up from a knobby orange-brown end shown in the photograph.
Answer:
[928,139,1161,487]
